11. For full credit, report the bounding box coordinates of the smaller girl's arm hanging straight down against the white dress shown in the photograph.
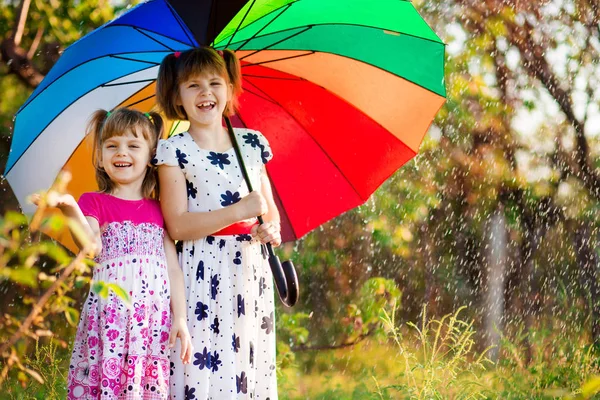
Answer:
[164,232,193,364]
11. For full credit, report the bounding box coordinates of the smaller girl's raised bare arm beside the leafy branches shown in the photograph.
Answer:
[31,193,102,254]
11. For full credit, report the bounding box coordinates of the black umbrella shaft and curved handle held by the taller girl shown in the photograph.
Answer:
[223,115,300,307]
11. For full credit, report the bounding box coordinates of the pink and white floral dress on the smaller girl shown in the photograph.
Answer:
[68,193,171,400]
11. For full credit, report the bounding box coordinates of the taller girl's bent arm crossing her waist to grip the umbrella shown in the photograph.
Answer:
[158,165,267,240]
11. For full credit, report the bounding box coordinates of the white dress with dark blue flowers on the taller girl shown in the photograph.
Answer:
[154,129,277,400]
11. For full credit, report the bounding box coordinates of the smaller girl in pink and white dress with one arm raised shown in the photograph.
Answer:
[33,108,192,400]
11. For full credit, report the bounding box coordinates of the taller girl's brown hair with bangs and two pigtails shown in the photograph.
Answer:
[156,46,242,120]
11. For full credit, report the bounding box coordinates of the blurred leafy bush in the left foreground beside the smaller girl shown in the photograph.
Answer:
[0,174,128,392]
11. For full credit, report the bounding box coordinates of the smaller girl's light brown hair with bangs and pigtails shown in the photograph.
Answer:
[86,108,163,198]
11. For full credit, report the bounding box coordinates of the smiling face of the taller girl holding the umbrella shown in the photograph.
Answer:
[177,72,231,125]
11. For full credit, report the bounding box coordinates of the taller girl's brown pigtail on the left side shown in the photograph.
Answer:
[156,53,187,120]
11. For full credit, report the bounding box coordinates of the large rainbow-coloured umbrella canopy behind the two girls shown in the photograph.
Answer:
[6,0,445,247]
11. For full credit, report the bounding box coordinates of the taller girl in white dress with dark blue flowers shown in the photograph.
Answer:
[155,47,281,400]
